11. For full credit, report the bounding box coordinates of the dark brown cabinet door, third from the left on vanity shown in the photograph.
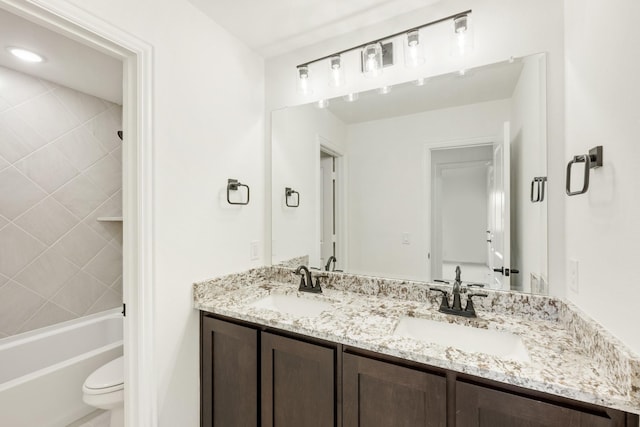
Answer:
[342,354,447,427]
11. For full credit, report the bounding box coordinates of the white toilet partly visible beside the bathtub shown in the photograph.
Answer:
[82,356,124,427]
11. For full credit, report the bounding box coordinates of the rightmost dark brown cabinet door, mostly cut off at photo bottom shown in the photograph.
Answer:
[456,381,626,427]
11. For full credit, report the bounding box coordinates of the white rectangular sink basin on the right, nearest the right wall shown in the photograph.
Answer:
[393,317,529,362]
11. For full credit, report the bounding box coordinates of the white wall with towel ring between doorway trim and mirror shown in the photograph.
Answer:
[32,0,264,426]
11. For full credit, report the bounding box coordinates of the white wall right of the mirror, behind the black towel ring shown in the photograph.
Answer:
[564,0,640,353]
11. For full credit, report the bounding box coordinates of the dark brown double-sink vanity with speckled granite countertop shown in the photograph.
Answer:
[194,267,640,427]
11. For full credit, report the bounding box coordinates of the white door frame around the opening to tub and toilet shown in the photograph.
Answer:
[0,0,157,427]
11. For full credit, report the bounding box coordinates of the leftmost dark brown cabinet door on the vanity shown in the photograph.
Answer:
[200,317,258,427]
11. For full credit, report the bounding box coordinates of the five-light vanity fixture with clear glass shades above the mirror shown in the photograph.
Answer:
[297,9,473,85]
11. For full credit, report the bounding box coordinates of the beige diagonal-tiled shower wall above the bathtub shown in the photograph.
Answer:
[0,67,122,338]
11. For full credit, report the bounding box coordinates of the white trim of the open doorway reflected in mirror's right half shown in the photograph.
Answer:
[422,136,496,281]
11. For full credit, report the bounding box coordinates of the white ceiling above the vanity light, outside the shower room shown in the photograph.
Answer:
[189,0,440,58]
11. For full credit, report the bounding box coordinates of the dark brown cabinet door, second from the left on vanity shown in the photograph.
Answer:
[261,332,336,427]
